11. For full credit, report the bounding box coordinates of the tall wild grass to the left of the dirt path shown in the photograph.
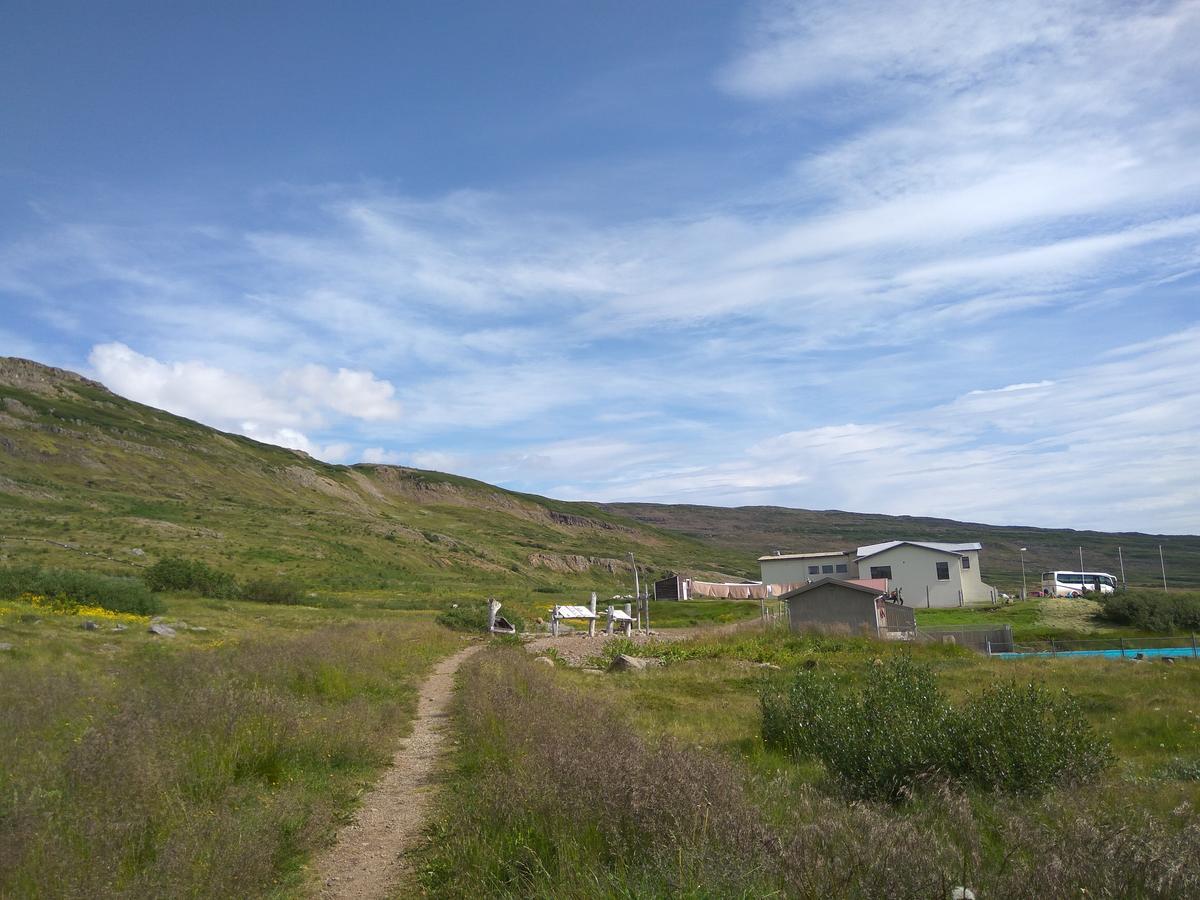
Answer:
[0,623,448,898]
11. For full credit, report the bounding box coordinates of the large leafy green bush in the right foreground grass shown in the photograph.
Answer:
[762,656,1111,799]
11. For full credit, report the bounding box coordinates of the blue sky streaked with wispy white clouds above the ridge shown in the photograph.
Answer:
[0,0,1200,533]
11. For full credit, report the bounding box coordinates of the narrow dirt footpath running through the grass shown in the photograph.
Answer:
[314,644,480,900]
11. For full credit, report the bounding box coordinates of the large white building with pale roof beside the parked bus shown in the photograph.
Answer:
[758,541,996,607]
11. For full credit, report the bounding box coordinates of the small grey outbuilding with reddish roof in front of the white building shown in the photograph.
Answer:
[780,578,913,637]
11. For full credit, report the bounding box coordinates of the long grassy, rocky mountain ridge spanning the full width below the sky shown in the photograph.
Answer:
[0,358,1200,595]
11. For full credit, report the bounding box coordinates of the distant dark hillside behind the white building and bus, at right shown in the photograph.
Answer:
[604,503,1200,590]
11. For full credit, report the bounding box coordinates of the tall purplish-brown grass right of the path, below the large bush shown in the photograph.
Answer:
[421,650,1200,898]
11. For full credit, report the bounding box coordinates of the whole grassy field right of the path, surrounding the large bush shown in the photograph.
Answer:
[422,632,1200,898]
